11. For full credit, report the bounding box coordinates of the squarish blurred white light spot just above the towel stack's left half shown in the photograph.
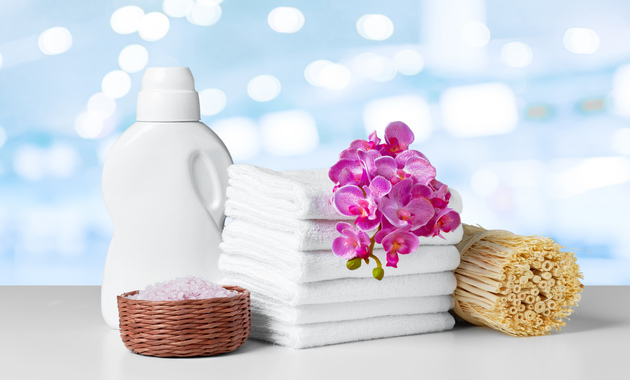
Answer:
[260,110,319,156]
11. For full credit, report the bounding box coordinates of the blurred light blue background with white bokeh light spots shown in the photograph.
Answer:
[0,0,630,285]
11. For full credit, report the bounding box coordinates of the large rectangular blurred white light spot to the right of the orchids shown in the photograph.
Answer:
[440,83,518,137]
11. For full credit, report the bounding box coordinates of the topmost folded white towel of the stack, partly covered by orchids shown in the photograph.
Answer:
[225,164,462,223]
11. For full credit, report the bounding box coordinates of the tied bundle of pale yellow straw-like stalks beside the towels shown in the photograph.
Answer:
[454,224,584,336]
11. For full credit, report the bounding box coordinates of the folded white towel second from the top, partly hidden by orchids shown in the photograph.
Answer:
[223,219,464,251]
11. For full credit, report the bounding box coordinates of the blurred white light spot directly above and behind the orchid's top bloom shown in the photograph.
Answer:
[363,95,432,142]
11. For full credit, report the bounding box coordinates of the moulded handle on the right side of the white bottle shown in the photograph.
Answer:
[190,150,231,231]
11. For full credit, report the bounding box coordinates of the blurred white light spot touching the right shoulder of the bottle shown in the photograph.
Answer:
[210,117,261,162]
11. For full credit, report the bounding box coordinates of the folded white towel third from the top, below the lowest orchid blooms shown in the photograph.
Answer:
[219,242,460,283]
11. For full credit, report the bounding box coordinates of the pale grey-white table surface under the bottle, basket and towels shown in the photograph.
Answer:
[0,286,630,380]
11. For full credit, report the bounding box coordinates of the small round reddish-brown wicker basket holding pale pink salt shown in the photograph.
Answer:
[118,286,251,357]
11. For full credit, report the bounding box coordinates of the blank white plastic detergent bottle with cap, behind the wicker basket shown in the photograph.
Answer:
[101,67,232,328]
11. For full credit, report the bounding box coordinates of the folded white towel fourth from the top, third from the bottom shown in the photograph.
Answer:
[221,270,457,306]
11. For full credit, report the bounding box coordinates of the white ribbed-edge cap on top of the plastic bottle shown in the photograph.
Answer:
[136,67,200,121]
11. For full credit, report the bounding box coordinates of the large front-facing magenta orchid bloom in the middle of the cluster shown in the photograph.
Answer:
[378,179,435,231]
